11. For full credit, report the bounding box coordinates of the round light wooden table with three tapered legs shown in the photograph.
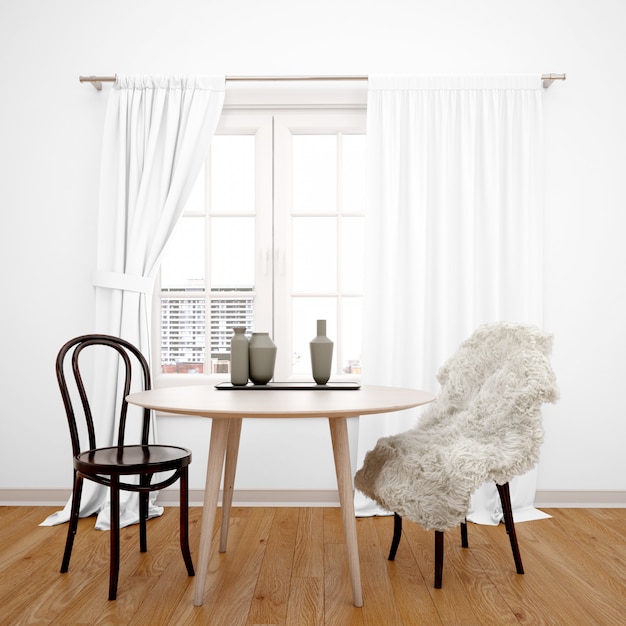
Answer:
[127,385,434,607]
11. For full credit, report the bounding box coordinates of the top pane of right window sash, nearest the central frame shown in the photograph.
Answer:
[292,135,337,213]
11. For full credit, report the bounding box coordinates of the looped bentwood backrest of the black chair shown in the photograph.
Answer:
[56,334,152,455]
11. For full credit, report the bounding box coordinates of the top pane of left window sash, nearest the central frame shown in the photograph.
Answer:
[211,135,255,213]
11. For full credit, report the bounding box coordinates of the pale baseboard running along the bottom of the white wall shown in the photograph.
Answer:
[0,489,626,509]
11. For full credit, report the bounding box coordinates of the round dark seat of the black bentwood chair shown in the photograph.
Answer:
[74,445,191,475]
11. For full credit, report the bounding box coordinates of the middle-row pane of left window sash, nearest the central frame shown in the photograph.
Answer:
[210,217,255,289]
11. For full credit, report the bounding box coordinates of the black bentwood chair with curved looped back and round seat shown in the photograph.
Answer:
[56,335,194,600]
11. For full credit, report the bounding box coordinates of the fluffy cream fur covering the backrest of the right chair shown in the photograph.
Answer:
[417,322,558,484]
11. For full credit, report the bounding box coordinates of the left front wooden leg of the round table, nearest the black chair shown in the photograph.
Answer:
[193,419,230,606]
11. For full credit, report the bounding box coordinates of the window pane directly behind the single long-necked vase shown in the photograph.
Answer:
[291,298,337,374]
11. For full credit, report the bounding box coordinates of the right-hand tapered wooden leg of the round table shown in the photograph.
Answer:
[328,417,363,607]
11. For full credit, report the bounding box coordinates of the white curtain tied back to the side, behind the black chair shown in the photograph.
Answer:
[44,76,225,528]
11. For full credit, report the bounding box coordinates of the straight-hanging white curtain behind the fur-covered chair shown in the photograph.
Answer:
[355,75,543,523]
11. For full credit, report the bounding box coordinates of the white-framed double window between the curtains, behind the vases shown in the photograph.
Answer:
[155,88,365,380]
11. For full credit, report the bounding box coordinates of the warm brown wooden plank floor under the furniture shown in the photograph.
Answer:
[0,507,626,626]
